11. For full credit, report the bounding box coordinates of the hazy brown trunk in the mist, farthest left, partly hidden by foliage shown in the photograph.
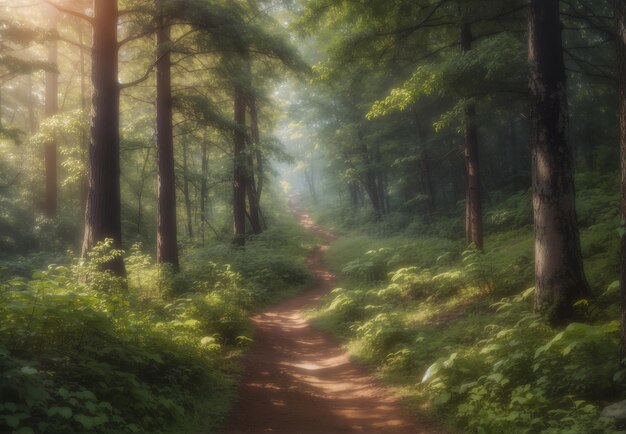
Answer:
[44,12,59,218]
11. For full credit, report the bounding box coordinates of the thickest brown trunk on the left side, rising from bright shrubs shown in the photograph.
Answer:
[83,0,126,275]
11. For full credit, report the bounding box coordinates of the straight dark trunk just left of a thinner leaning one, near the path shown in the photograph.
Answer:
[233,88,246,246]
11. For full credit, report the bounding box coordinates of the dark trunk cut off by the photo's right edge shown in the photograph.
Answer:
[615,0,626,365]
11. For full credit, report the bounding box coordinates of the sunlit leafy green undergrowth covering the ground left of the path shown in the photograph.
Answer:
[0,214,314,434]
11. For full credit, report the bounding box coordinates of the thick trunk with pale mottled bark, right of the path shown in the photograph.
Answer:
[528,0,590,325]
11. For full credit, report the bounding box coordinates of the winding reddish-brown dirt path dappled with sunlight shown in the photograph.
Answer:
[219,212,443,434]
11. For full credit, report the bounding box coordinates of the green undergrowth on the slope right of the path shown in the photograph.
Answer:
[312,177,626,434]
